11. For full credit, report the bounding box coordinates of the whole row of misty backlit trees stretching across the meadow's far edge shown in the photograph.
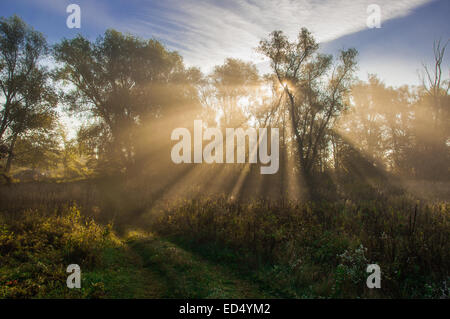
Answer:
[0,16,450,190]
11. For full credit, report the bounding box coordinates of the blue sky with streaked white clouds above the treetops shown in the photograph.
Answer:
[0,0,450,86]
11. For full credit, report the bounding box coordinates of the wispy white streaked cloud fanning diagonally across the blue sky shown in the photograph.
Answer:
[128,0,431,69]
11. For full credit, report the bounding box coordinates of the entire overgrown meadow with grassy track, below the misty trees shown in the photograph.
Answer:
[0,182,450,298]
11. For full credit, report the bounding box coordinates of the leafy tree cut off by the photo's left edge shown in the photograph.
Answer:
[0,16,57,172]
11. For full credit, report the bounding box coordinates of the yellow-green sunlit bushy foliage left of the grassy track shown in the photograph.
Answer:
[0,206,122,298]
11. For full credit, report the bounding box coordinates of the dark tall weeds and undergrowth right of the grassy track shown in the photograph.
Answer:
[153,198,450,298]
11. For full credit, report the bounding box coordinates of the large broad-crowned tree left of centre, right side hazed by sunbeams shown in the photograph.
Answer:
[54,30,201,170]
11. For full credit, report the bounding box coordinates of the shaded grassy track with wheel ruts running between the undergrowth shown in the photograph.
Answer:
[127,234,270,298]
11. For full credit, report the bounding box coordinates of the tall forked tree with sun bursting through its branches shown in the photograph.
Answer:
[258,28,357,179]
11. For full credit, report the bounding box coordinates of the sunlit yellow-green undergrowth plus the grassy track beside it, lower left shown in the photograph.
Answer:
[0,206,272,298]
